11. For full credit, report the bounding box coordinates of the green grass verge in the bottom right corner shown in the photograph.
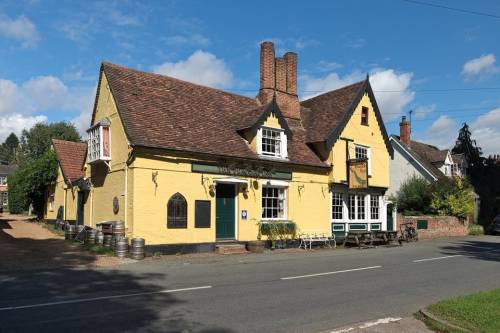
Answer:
[425,289,500,333]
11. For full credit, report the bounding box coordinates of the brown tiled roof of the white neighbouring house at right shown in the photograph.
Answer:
[391,135,449,179]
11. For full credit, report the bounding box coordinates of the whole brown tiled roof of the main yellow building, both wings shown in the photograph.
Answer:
[92,62,392,167]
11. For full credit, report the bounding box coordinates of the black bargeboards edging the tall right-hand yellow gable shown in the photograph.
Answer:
[326,75,394,158]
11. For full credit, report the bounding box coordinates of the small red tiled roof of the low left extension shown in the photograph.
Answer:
[52,139,87,182]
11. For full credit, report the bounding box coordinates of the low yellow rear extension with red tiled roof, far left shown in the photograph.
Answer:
[44,139,87,224]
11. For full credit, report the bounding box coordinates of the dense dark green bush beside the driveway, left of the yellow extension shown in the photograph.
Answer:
[9,150,58,217]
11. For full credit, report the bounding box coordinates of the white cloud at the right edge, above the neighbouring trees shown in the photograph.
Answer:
[470,108,500,156]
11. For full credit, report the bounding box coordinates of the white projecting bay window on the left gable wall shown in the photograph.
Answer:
[87,119,111,163]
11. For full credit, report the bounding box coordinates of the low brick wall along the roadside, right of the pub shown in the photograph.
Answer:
[397,214,469,239]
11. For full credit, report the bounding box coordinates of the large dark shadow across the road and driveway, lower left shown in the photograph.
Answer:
[0,214,237,333]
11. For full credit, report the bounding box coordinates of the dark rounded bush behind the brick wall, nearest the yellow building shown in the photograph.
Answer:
[396,176,432,215]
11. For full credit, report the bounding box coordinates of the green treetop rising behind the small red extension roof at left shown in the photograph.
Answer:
[21,122,81,161]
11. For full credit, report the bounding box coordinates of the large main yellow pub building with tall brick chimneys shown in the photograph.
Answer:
[81,42,392,249]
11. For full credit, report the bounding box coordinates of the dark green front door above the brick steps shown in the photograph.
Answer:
[215,184,235,239]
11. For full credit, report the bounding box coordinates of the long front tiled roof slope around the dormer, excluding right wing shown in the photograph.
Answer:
[101,62,327,167]
